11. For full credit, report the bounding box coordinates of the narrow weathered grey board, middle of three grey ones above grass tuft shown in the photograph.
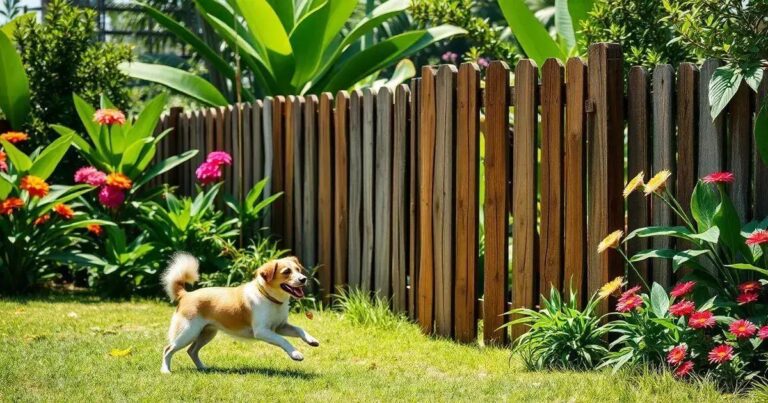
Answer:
[360,88,376,291]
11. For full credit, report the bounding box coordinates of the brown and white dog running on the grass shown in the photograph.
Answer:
[160,253,320,373]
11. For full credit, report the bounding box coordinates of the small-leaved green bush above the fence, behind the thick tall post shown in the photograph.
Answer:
[577,0,692,70]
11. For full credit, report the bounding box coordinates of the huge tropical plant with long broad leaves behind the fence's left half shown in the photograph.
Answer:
[123,0,465,105]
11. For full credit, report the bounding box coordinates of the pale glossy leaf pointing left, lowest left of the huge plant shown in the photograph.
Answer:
[120,62,229,106]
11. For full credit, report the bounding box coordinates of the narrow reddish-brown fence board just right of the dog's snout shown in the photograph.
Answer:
[317,92,334,302]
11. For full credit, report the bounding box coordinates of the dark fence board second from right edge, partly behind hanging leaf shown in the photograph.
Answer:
[728,82,752,222]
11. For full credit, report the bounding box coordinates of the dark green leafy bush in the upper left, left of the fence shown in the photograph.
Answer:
[15,0,132,152]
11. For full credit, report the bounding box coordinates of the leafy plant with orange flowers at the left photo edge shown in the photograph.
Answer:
[0,132,112,293]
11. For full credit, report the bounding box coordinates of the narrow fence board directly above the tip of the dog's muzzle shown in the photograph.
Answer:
[301,95,318,267]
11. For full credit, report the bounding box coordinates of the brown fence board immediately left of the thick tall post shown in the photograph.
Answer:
[563,58,587,301]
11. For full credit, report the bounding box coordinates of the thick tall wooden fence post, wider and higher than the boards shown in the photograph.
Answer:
[587,43,624,313]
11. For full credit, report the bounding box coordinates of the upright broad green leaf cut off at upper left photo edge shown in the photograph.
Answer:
[0,32,30,130]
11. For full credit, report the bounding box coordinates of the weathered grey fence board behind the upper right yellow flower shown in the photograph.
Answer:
[651,64,676,287]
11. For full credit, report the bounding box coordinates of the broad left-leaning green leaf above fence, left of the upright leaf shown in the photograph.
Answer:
[499,0,568,66]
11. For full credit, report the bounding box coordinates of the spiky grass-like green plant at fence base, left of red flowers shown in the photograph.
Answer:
[503,287,608,370]
